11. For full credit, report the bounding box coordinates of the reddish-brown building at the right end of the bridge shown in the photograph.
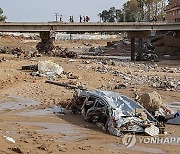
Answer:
[165,0,180,22]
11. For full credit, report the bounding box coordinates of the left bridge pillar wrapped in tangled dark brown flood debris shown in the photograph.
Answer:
[36,31,55,55]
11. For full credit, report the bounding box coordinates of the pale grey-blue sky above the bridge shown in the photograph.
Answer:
[0,0,128,22]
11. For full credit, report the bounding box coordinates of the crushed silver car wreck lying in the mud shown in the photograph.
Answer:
[71,90,165,136]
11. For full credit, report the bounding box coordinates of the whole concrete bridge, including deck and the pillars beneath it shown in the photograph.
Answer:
[0,22,180,60]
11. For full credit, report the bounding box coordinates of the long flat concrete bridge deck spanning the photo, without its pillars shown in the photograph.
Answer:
[0,22,180,32]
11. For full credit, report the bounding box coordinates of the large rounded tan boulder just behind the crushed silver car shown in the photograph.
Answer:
[140,91,163,112]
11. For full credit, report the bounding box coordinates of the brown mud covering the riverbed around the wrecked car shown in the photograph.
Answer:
[0,35,180,154]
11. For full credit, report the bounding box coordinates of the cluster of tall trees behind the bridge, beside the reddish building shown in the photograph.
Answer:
[99,0,167,22]
